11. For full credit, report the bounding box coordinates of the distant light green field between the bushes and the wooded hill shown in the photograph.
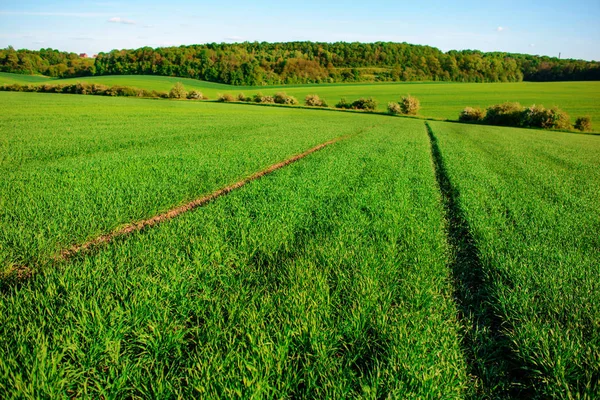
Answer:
[0,74,600,122]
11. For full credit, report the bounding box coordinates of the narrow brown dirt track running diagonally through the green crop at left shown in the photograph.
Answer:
[54,136,348,261]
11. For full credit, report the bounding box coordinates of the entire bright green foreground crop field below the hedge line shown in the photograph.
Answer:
[0,91,600,399]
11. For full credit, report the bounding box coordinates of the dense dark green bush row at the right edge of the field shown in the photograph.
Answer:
[458,103,592,131]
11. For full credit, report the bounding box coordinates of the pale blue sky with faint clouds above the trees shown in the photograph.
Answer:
[0,0,600,60]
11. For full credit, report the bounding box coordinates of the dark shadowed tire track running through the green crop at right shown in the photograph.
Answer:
[425,122,532,399]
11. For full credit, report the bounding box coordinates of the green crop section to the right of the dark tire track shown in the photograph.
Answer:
[431,123,600,398]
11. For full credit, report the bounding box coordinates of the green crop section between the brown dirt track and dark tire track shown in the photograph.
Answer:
[0,118,467,398]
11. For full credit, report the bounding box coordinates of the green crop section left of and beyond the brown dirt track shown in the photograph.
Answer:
[0,92,381,267]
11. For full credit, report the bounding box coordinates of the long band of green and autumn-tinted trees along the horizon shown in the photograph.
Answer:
[0,42,600,86]
